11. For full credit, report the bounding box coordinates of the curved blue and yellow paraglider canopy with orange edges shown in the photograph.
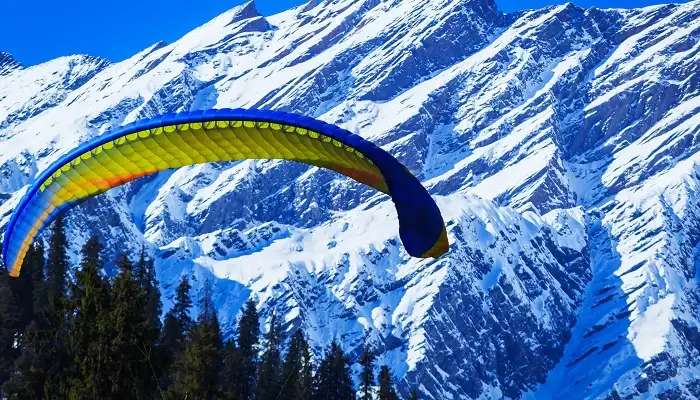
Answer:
[3,109,448,276]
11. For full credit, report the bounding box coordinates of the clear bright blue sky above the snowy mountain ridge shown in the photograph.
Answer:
[0,0,678,65]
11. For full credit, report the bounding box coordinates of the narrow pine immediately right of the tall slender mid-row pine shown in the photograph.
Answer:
[256,311,282,400]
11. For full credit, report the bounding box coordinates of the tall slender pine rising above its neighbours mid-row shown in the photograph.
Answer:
[236,299,260,400]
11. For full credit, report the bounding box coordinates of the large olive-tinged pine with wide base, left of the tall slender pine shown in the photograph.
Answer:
[168,283,222,400]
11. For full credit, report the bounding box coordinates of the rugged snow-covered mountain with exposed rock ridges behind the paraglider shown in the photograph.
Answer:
[0,0,700,399]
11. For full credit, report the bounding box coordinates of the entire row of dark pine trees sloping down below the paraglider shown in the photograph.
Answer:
[0,218,418,400]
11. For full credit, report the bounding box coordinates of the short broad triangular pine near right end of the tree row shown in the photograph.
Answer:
[313,342,355,400]
